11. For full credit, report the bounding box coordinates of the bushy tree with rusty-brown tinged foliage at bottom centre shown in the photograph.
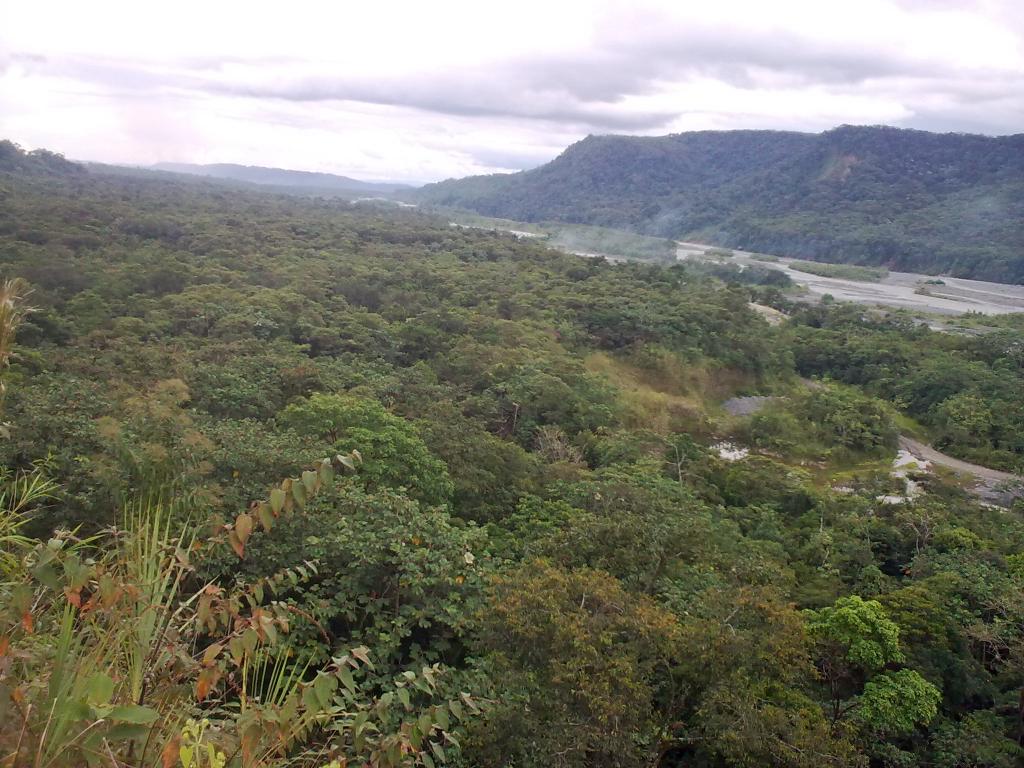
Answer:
[475,561,679,768]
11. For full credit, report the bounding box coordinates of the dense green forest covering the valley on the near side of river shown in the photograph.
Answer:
[0,137,1024,768]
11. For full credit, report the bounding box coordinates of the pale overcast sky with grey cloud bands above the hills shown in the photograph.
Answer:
[0,0,1024,182]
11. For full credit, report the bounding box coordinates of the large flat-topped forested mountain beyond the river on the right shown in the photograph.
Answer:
[408,126,1024,283]
